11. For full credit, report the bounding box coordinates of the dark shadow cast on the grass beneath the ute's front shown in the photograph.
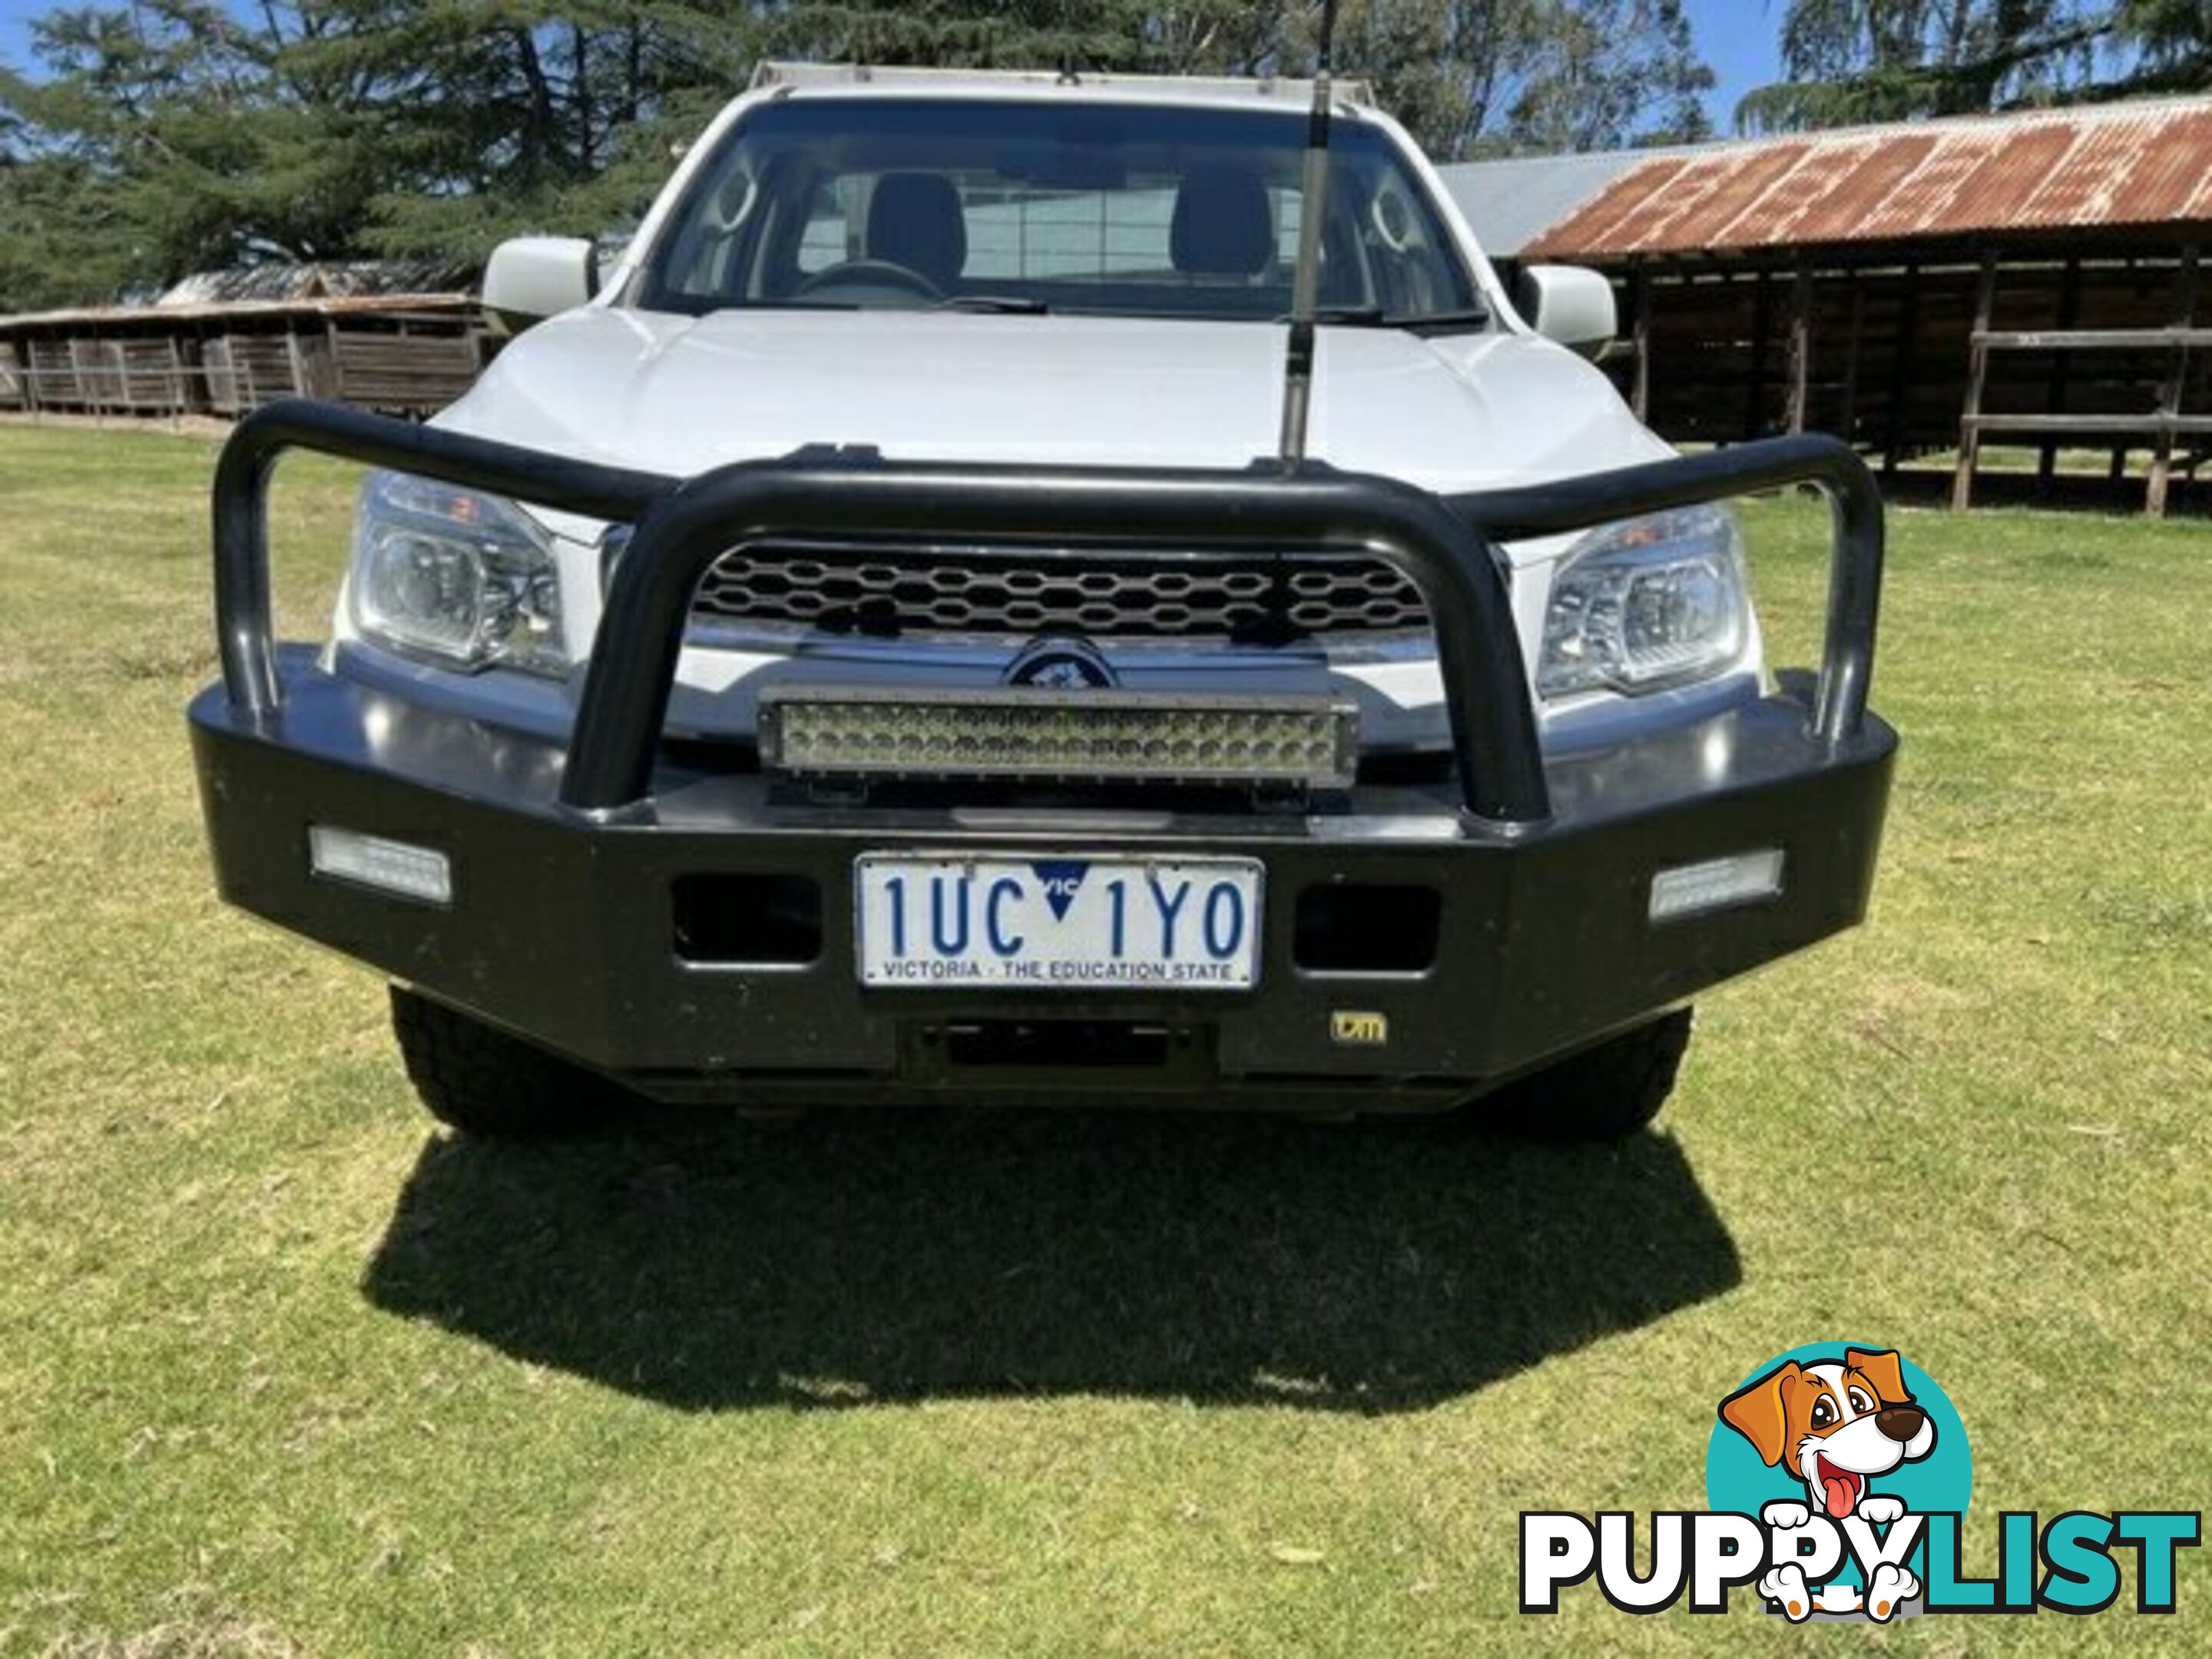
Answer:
[365,1111,1741,1411]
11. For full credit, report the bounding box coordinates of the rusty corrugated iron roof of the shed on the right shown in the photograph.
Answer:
[1526,98,2212,259]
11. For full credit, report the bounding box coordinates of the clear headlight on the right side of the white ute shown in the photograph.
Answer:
[1535,507,1752,697]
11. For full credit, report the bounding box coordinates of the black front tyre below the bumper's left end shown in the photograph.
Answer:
[392,985,619,1139]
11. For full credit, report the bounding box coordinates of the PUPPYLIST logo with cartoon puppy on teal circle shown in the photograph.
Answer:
[1520,1343,2203,1624]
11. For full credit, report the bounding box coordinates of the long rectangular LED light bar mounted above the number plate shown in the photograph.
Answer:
[759,686,1360,787]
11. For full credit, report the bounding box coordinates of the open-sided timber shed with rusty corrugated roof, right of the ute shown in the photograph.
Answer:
[1445,98,2212,513]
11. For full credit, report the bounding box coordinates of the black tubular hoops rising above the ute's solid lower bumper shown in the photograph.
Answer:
[214,400,1883,827]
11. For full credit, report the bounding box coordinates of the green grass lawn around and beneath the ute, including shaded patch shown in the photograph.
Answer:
[0,429,2212,1654]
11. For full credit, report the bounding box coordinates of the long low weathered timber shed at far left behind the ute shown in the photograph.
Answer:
[0,294,491,418]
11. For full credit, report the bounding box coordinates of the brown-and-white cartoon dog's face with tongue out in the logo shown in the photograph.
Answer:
[1721,1347,1936,1520]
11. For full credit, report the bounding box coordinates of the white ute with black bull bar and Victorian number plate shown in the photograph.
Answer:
[193,65,1896,1134]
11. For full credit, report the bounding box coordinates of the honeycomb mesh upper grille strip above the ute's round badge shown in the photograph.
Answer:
[692,546,1429,639]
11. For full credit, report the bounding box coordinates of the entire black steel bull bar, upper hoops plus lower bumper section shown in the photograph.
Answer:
[190,405,1896,1106]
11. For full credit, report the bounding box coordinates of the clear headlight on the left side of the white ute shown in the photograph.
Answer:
[349,471,568,674]
